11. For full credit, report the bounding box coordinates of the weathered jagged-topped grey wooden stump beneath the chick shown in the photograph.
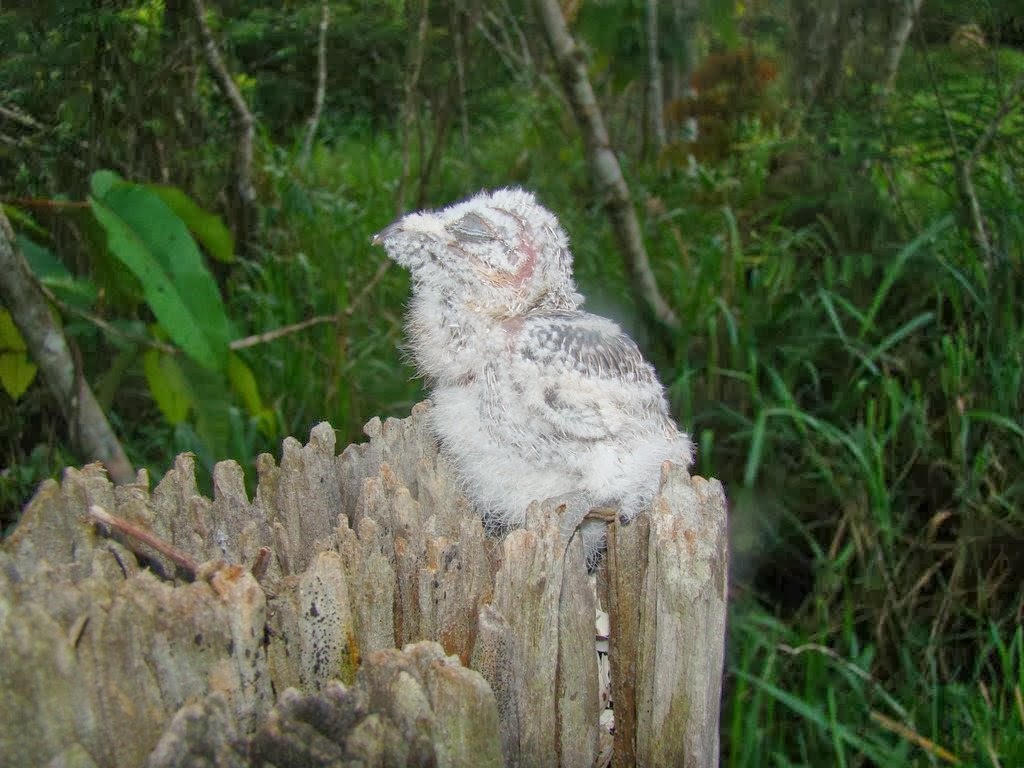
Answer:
[0,403,727,768]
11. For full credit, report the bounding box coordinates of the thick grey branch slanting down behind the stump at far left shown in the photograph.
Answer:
[0,209,135,483]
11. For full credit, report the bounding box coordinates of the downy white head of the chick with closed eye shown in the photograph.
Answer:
[373,188,582,315]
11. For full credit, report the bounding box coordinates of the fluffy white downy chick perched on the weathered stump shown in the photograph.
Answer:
[373,188,693,562]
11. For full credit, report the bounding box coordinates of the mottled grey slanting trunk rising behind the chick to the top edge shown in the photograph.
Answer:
[537,0,679,330]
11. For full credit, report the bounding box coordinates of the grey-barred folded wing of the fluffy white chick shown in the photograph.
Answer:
[512,312,668,441]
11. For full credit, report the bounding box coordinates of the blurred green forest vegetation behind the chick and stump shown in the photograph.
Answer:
[0,0,1024,767]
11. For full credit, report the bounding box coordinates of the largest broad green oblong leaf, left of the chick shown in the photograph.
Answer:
[90,180,232,370]
